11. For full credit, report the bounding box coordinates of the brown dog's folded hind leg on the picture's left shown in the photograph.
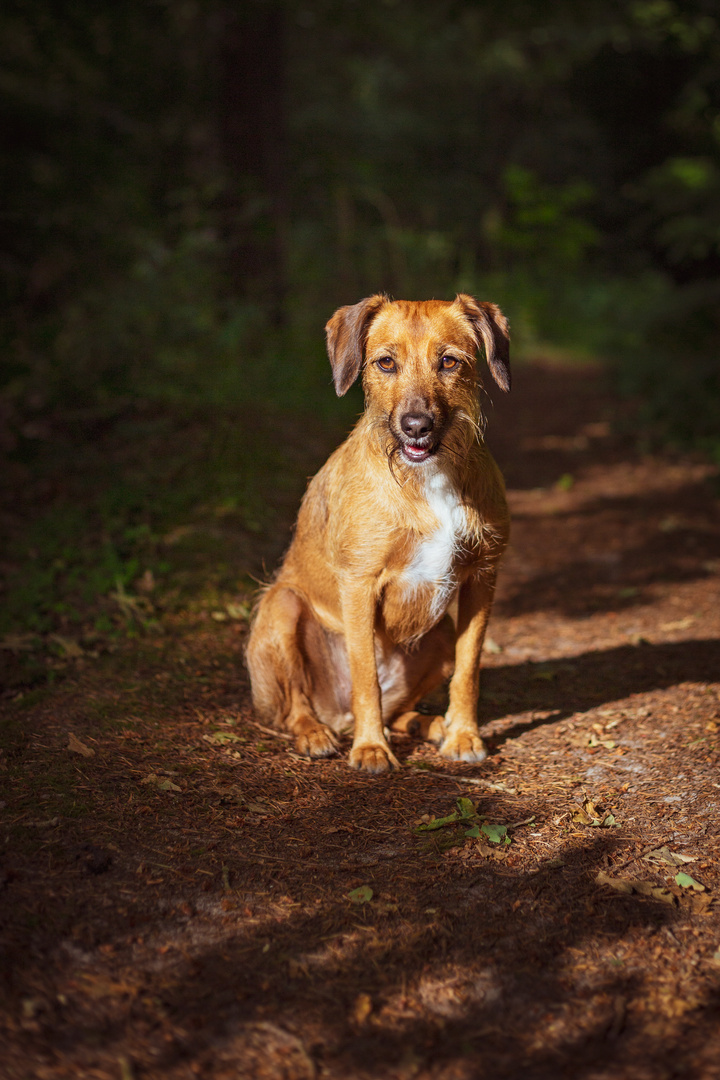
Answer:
[245,585,338,757]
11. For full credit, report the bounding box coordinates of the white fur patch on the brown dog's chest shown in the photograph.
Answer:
[403,472,467,620]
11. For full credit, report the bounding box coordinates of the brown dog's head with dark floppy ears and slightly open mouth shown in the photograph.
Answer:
[326,294,510,464]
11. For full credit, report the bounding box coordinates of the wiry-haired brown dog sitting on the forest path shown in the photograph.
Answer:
[247,295,510,772]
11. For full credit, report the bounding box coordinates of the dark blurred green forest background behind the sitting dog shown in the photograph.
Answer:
[0,0,720,656]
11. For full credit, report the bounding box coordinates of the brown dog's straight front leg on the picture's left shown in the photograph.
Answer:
[342,580,399,772]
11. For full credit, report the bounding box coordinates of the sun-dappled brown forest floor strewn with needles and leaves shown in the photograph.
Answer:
[0,363,720,1080]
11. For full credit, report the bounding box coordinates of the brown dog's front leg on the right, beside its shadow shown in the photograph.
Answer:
[430,572,495,761]
